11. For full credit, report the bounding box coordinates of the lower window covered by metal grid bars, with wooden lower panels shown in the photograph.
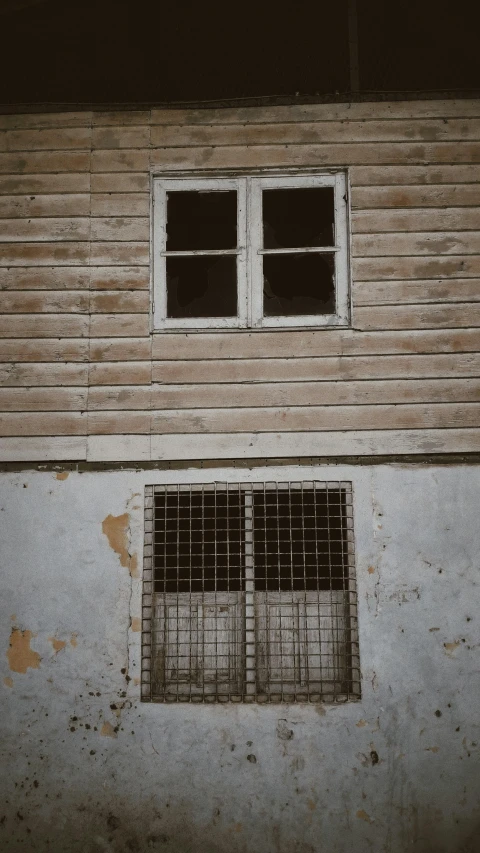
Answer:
[142,481,360,702]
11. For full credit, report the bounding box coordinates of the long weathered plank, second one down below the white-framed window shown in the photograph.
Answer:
[152,353,480,382]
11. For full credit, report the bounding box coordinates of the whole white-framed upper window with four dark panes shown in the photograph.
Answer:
[153,172,350,330]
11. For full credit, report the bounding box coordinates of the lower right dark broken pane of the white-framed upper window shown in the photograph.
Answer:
[263,252,335,317]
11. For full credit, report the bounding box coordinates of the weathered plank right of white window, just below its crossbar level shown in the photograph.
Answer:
[352,255,480,281]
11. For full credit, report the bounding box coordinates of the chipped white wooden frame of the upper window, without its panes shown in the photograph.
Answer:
[152,170,351,332]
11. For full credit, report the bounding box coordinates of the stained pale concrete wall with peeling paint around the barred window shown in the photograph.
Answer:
[0,465,480,853]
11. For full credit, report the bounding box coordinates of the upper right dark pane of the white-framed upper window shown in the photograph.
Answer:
[263,187,334,249]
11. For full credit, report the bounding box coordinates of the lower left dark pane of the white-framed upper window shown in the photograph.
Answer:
[166,255,237,317]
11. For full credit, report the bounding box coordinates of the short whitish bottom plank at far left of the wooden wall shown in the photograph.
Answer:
[0,436,87,462]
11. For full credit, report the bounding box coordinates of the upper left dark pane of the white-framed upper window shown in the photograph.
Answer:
[167,191,237,252]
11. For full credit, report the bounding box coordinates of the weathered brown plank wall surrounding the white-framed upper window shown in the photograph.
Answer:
[0,100,480,461]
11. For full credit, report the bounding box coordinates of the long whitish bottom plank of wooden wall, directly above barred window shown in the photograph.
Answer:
[147,429,480,460]
